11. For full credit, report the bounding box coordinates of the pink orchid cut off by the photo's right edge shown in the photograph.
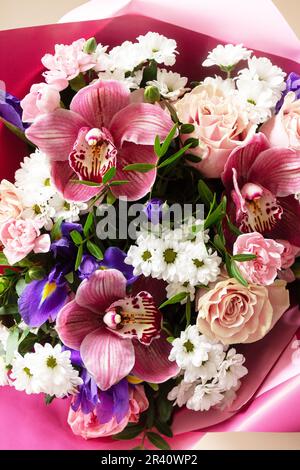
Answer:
[222,133,300,246]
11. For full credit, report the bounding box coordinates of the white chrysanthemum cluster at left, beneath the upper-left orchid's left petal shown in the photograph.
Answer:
[15,150,87,230]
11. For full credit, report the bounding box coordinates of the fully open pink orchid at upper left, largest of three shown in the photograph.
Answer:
[26,80,173,201]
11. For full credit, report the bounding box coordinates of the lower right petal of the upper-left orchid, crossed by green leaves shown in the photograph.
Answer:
[111,142,157,201]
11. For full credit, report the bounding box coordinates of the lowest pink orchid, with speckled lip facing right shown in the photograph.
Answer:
[56,269,178,390]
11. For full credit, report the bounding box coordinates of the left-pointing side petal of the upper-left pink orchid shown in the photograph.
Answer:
[26,109,86,161]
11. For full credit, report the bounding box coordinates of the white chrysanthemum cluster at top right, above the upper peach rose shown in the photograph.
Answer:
[202,44,286,124]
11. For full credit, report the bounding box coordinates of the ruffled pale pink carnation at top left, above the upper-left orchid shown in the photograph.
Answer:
[42,39,95,90]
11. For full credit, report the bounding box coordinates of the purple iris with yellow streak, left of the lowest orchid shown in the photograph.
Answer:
[18,268,68,327]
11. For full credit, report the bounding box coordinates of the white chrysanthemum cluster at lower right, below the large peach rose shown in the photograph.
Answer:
[168,325,248,411]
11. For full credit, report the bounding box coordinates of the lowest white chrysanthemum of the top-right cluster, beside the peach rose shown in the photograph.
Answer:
[236,78,277,124]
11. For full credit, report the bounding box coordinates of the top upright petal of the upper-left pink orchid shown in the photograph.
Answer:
[70,80,130,129]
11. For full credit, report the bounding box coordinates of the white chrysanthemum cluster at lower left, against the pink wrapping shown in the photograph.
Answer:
[8,343,82,398]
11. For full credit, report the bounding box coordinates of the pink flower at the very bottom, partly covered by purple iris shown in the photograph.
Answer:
[68,385,149,439]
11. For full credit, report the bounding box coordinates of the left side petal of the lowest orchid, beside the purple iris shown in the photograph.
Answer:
[56,300,101,350]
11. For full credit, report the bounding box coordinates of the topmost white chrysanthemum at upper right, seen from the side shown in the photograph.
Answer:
[202,44,252,69]
